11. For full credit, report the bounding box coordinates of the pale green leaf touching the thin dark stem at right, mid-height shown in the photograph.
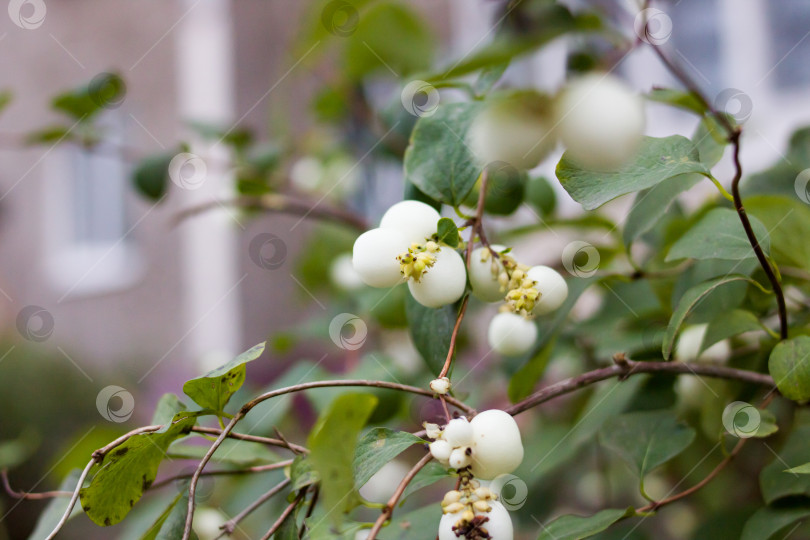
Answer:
[666,208,770,262]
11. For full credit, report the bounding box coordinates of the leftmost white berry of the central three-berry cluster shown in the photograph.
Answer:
[352,229,408,287]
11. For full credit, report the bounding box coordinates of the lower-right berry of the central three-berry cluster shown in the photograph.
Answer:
[408,246,467,308]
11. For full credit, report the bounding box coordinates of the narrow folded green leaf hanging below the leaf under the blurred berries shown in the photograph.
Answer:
[622,174,701,246]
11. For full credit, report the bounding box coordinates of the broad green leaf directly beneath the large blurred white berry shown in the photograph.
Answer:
[557,135,710,210]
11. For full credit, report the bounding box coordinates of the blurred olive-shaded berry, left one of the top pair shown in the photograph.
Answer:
[468,92,557,169]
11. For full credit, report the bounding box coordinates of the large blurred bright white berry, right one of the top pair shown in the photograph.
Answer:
[556,73,644,170]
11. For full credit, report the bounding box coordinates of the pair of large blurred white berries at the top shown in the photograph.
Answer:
[468,73,645,170]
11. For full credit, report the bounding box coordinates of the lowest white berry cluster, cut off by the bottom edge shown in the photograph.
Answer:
[425,409,523,540]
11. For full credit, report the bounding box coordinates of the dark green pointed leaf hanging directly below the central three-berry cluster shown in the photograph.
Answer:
[405,294,456,373]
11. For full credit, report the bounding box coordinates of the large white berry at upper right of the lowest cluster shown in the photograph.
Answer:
[470,409,523,480]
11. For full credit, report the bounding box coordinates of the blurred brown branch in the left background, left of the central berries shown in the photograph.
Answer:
[177,193,369,231]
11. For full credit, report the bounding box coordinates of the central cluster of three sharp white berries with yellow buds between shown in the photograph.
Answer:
[352,201,467,308]
